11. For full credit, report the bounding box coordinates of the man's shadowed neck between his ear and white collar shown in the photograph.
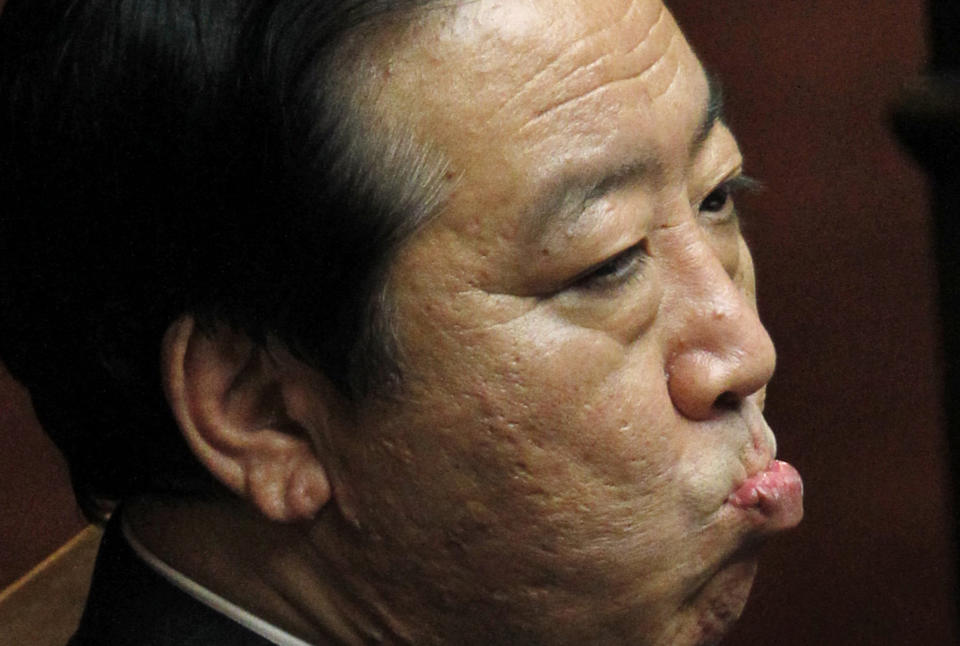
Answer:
[124,498,406,646]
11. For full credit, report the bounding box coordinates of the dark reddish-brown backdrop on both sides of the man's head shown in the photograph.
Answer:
[0,0,957,646]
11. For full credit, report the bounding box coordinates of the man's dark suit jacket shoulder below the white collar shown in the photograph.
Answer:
[68,514,272,646]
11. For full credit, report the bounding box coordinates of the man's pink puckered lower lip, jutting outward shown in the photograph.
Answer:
[727,460,803,531]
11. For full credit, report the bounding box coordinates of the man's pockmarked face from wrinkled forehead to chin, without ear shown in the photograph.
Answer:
[322,0,801,644]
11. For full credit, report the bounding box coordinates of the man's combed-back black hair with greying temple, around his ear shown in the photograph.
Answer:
[0,0,443,515]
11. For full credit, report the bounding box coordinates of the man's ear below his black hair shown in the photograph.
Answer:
[162,316,330,521]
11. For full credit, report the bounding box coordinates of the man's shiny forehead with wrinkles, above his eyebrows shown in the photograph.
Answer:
[375,0,708,233]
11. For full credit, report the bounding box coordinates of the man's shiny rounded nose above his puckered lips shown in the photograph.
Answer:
[666,230,776,420]
